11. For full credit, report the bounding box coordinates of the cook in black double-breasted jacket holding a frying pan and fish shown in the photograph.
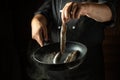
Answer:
[27,0,116,80]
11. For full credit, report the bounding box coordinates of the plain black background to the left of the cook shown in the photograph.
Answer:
[0,0,43,80]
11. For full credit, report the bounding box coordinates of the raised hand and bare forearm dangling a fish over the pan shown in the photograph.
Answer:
[61,2,112,22]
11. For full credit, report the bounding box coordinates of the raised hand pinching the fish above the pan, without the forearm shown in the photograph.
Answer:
[61,2,86,22]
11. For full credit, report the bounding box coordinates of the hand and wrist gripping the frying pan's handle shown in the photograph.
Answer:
[31,14,48,47]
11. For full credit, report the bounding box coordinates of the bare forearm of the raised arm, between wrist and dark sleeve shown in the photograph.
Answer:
[81,3,112,22]
